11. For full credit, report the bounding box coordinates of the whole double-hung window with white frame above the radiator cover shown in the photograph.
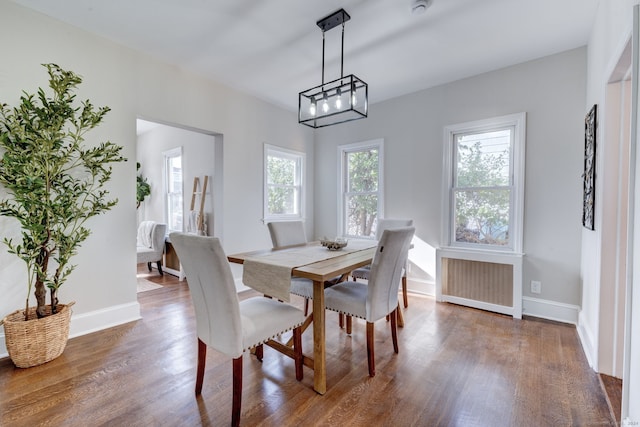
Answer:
[443,113,525,253]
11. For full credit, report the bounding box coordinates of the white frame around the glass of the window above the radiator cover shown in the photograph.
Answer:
[441,112,526,253]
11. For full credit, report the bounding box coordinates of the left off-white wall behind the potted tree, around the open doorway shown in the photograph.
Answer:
[0,1,314,356]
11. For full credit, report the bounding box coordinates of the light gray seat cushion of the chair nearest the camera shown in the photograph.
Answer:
[240,297,305,350]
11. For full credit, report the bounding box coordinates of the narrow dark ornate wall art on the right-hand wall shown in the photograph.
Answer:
[582,104,598,230]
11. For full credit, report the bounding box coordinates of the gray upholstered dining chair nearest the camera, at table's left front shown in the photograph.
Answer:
[170,233,305,426]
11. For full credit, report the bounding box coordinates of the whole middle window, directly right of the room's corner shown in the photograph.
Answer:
[338,139,384,237]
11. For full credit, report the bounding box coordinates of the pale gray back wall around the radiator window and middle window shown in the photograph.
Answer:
[315,48,586,322]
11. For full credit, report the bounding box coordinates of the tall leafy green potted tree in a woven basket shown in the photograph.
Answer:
[0,64,126,367]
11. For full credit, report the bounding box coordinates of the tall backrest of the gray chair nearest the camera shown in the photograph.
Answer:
[170,233,242,358]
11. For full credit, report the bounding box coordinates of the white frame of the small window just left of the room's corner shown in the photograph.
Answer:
[263,144,307,223]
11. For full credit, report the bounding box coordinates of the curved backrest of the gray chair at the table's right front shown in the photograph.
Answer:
[366,227,415,322]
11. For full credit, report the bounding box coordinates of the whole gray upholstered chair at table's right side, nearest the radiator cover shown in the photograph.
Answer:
[324,227,415,377]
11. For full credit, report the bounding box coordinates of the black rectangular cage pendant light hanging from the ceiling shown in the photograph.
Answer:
[298,9,369,128]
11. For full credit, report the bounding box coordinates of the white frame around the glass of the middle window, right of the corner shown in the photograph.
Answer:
[337,138,384,239]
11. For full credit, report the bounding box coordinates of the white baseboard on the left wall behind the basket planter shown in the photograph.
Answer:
[0,301,142,358]
